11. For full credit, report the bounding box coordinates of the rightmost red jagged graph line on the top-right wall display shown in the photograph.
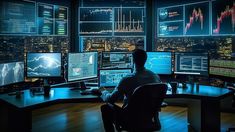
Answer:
[213,3,235,34]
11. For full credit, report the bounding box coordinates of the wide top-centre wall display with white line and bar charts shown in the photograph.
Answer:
[79,7,145,36]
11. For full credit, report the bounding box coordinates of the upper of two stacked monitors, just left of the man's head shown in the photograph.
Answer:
[101,52,133,69]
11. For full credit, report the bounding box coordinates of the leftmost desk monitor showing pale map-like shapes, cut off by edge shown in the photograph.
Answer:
[0,61,24,86]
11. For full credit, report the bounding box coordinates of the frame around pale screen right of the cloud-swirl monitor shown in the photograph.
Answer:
[66,51,99,82]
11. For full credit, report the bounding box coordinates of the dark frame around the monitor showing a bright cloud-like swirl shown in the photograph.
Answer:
[25,52,63,78]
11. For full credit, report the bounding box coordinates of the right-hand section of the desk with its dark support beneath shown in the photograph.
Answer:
[166,84,234,132]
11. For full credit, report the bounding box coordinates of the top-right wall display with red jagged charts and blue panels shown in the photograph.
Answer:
[157,0,235,37]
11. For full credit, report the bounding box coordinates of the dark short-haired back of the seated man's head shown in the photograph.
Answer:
[132,49,147,67]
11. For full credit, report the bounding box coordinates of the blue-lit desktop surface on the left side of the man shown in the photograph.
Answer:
[0,87,99,108]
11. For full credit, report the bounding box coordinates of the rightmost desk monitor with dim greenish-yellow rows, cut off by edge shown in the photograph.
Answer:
[210,59,235,79]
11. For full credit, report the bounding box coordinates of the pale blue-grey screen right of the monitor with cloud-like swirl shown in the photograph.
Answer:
[68,52,98,81]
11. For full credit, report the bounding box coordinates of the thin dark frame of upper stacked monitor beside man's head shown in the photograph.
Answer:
[100,51,134,69]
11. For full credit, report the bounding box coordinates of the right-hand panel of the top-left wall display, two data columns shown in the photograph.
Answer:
[37,3,68,36]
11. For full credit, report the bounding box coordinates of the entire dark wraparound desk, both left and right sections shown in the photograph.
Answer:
[0,85,233,132]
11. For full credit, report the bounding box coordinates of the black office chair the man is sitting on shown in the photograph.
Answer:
[114,83,167,132]
